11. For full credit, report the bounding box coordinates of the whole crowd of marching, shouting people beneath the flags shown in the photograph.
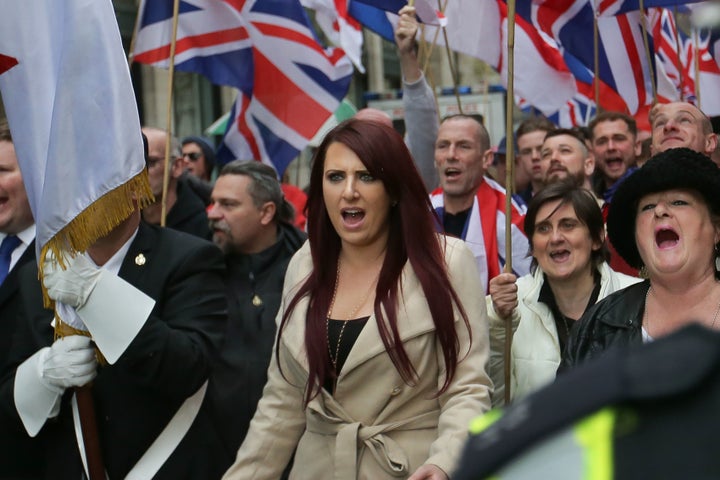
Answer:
[0,6,720,480]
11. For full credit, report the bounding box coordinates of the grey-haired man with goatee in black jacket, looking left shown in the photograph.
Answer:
[205,160,306,467]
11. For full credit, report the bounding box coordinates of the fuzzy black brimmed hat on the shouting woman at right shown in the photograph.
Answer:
[607,148,720,268]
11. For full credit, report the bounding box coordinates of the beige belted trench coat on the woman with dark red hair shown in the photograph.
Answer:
[224,238,492,480]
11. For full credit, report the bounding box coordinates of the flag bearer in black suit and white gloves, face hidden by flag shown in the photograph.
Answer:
[0,211,227,479]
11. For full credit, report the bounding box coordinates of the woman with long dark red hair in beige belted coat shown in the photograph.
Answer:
[225,119,491,480]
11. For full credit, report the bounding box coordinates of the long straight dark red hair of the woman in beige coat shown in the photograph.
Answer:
[275,119,472,403]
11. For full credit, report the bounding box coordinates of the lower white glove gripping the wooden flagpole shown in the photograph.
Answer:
[39,335,97,393]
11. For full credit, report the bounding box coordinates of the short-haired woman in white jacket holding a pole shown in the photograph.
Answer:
[487,182,640,405]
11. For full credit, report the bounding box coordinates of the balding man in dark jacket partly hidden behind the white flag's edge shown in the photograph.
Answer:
[142,127,210,240]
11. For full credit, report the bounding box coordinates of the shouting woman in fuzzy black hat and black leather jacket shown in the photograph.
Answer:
[563,148,720,367]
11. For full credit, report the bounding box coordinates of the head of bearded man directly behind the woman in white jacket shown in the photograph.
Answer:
[540,128,595,190]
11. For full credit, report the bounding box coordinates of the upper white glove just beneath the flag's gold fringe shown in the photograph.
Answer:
[42,251,102,308]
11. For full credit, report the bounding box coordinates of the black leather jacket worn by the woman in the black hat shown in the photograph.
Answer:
[558,280,650,372]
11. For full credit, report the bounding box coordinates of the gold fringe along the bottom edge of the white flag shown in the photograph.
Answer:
[38,169,155,308]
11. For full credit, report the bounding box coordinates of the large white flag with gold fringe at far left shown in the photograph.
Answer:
[0,0,152,258]
